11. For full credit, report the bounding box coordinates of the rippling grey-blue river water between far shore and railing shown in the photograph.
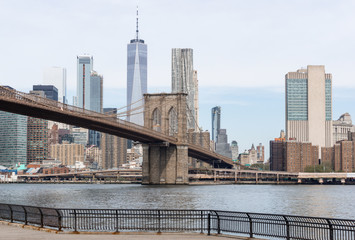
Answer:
[0,184,355,219]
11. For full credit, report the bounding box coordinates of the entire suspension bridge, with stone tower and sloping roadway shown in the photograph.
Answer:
[0,86,234,184]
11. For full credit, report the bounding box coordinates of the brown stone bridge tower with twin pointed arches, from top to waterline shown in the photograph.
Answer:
[142,93,189,184]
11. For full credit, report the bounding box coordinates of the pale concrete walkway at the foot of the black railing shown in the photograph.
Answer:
[0,221,262,240]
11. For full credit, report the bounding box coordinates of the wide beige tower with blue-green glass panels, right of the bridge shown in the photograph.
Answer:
[285,66,332,153]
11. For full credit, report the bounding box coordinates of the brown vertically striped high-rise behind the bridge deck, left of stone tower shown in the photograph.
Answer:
[101,108,127,169]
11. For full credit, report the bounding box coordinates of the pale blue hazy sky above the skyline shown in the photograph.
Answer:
[0,0,355,158]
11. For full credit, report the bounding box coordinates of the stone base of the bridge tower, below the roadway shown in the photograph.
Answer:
[142,144,189,185]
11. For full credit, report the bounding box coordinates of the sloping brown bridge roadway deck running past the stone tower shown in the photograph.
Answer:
[0,86,233,168]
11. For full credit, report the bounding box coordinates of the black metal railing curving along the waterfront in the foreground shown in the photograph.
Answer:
[0,204,355,240]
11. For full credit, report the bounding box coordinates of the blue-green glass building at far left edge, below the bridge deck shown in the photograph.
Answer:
[0,111,27,167]
